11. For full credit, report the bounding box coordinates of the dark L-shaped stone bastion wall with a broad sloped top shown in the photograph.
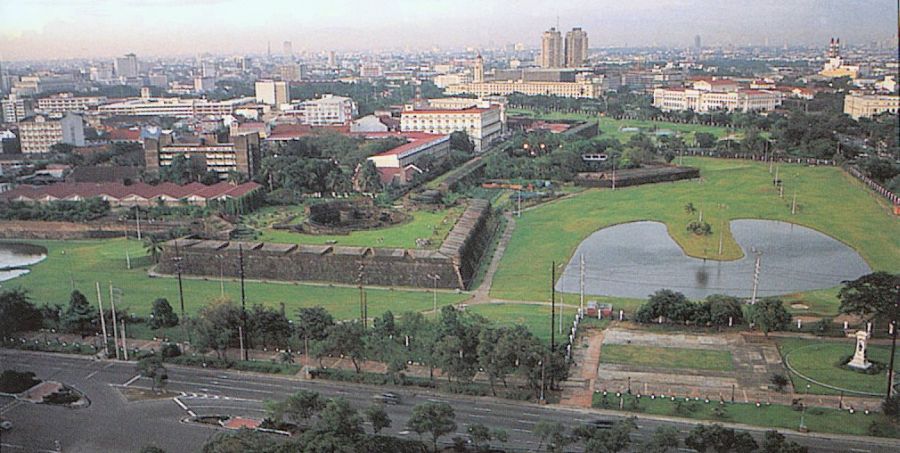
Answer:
[157,200,490,289]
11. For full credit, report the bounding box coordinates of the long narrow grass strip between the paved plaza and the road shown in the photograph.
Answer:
[594,393,900,437]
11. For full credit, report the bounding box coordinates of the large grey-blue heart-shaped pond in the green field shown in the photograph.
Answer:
[556,220,871,299]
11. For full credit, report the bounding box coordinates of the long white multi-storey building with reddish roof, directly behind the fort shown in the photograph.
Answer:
[400,106,503,151]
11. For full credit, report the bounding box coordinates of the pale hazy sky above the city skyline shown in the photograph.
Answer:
[0,0,898,60]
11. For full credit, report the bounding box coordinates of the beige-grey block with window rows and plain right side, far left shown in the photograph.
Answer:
[19,113,84,154]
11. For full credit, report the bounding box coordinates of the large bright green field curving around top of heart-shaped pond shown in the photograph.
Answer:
[491,154,900,308]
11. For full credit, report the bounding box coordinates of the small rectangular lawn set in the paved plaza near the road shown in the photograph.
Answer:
[600,344,734,371]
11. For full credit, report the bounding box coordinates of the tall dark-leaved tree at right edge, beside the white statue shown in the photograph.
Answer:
[838,272,900,398]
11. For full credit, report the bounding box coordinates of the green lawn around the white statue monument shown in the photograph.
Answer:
[777,338,900,395]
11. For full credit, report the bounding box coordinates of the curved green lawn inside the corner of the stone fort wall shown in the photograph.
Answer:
[257,207,463,249]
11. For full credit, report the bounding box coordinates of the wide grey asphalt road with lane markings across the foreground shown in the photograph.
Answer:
[0,350,900,453]
